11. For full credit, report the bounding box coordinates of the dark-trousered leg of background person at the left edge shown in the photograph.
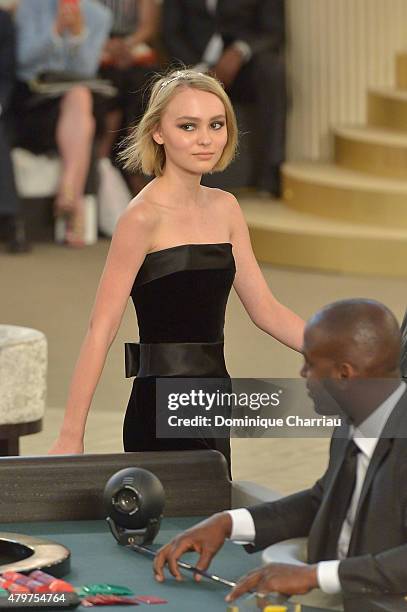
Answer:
[0,119,29,253]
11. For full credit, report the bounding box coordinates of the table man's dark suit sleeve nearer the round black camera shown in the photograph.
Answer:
[245,478,324,553]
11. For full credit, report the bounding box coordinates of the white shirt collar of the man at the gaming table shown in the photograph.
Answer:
[350,382,406,459]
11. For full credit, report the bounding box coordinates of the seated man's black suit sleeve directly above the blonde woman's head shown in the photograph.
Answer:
[162,0,201,65]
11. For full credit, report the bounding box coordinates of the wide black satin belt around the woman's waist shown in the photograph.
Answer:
[125,342,228,378]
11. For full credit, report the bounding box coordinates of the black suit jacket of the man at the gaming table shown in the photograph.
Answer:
[247,392,407,595]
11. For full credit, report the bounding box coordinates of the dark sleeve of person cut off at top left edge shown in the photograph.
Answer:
[0,11,15,115]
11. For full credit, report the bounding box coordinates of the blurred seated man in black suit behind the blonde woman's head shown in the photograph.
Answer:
[162,0,287,196]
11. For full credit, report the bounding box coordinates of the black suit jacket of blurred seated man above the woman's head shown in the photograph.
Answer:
[162,0,285,65]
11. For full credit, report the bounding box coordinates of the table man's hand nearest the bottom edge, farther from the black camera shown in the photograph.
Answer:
[226,563,318,601]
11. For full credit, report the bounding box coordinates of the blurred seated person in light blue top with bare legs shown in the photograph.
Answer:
[14,0,111,247]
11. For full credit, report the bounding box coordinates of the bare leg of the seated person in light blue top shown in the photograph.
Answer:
[55,85,95,246]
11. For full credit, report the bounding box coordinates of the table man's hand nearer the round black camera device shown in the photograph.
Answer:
[153,512,232,582]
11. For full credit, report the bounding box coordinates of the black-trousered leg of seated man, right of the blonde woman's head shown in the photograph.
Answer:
[230,51,287,197]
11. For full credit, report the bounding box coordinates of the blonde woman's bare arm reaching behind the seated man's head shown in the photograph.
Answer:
[226,194,304,351]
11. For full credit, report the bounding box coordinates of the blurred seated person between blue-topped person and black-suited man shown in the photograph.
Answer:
[98,0,160,194]
